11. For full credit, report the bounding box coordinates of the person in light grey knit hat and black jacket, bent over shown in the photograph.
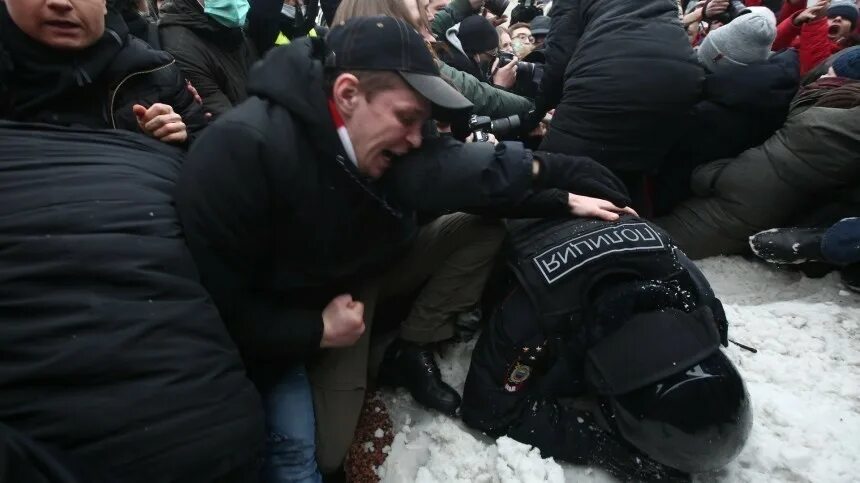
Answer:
[654,7,800,216]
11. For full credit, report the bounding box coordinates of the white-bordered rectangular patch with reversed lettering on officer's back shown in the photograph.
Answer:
[533,223,666,285]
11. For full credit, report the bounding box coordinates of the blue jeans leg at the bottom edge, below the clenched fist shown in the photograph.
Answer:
[255,366,322,483]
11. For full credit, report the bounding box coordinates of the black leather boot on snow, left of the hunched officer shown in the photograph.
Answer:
[379,339,460,414]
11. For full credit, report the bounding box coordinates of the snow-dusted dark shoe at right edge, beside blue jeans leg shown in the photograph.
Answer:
[750,228,827,265]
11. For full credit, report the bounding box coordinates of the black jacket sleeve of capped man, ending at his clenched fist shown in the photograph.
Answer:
[176,122,323,361]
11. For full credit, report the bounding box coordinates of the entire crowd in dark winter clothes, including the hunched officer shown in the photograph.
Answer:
[0,0,860,483]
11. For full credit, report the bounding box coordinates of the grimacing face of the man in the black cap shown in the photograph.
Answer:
[344,80,430,179]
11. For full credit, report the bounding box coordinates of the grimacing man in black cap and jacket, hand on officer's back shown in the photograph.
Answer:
[177,17,627,481]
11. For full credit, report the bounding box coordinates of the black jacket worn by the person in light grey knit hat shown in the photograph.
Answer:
[654,49,800,216]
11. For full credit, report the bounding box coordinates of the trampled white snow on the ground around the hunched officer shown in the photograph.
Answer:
[379,257,860,483]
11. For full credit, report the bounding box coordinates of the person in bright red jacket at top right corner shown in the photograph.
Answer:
[773,0,858,75]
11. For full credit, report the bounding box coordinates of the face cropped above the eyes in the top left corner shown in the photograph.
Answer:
[6,0,107,50]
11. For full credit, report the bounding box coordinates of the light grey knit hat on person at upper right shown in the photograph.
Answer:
[699,7,776,72]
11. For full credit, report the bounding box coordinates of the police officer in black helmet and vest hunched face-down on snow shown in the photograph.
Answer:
[462,216,752,481]
